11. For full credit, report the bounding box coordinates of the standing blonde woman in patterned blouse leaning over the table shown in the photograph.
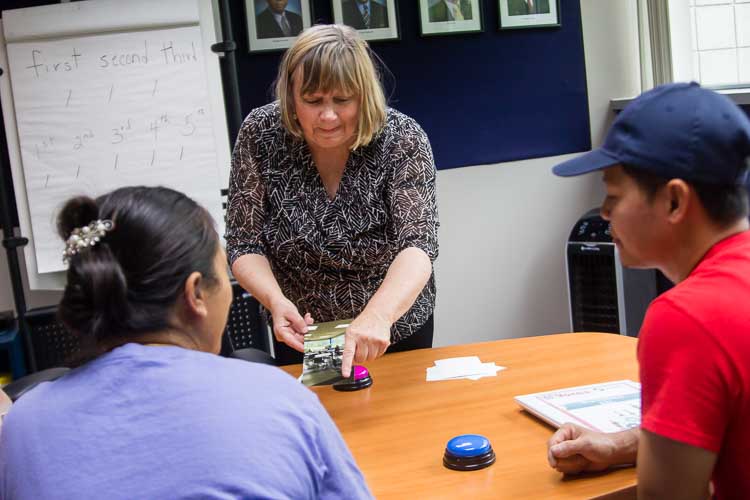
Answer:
[226,25,438,376]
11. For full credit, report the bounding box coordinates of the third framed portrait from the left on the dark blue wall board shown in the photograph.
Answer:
[419,0,484,36]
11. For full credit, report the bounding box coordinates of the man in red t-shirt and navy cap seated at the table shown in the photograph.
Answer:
[548,83,750,498]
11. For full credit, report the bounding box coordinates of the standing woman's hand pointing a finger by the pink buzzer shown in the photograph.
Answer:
[341,310,391,377]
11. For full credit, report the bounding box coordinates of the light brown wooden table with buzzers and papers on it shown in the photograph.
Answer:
[285,333,638,499]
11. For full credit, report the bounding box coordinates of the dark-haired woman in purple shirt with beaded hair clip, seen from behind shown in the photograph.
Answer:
[0,187,371,500]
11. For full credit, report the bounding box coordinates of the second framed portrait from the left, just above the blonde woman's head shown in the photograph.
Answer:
[331,0,402,41]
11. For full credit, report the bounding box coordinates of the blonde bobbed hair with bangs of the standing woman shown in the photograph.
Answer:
[276,24,386,150]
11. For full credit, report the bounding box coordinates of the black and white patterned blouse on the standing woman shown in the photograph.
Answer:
[226,103,439,343]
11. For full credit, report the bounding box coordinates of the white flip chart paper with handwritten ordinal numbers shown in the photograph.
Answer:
[8,26,223,273]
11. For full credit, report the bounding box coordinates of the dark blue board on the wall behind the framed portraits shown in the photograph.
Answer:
[230,0,591,169]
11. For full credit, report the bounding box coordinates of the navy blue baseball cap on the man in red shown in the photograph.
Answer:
[552,82,750,185]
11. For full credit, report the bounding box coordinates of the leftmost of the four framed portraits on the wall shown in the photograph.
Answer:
[245,0,311,52]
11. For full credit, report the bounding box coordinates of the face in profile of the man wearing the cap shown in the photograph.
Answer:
[601,165,668,267]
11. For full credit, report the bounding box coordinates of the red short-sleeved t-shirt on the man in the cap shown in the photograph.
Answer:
[638,231,750,498]
